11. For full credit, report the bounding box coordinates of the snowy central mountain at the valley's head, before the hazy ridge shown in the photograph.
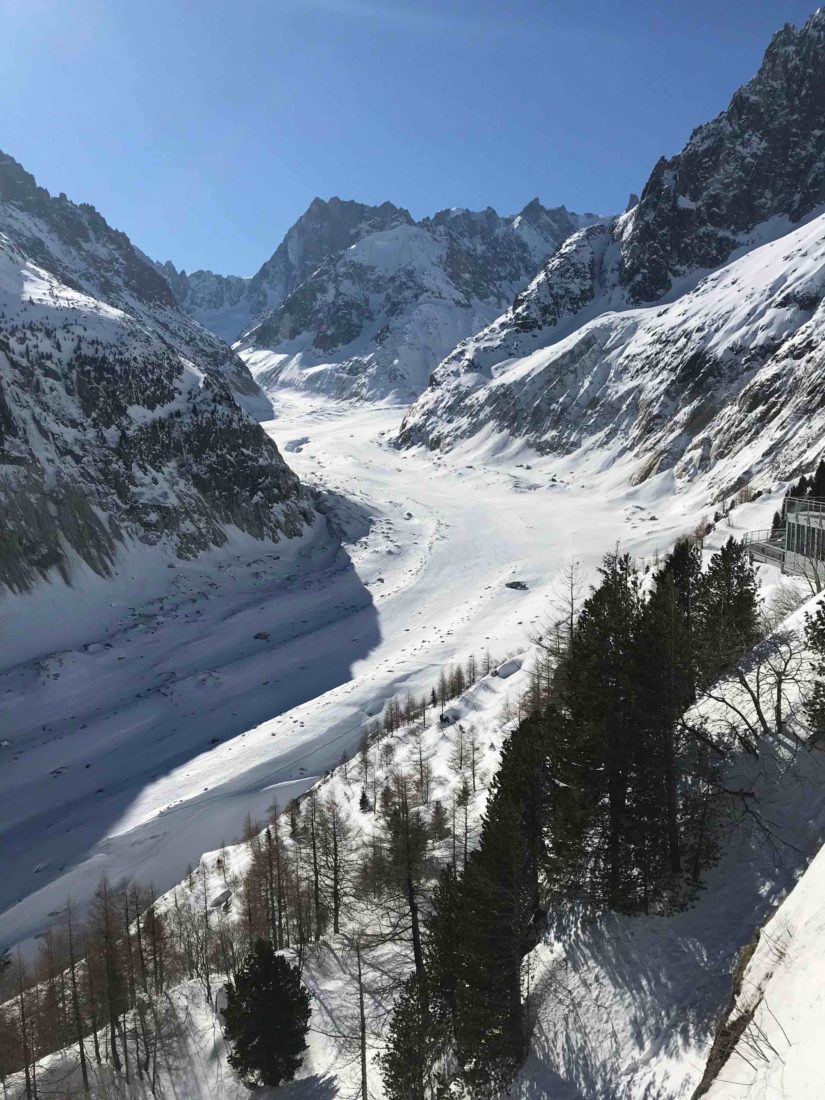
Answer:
[239,200,596,400]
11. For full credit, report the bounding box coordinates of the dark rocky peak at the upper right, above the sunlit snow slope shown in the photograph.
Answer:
[619,10,825,301]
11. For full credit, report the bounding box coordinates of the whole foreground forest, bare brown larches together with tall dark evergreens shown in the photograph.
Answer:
[0,530,825,1100]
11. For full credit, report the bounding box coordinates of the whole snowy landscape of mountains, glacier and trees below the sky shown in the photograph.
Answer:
[0,6,825,1100]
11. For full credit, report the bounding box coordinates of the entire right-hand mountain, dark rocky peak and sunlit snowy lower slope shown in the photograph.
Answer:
[400,10,825,490]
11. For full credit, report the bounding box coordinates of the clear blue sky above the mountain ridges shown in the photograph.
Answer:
[0,0,815,274]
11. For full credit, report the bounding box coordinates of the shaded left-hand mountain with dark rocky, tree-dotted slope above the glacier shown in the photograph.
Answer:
[0,154,314,591]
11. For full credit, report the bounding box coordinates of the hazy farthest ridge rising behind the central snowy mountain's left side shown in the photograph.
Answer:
[155,198,413,343]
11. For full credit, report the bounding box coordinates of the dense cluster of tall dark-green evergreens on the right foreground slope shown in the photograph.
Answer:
[383,540,783,1100]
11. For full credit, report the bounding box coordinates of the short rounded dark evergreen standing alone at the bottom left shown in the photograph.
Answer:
[223,939,310,1087]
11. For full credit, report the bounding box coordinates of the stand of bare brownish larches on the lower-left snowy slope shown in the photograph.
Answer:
[0,651,496,1100]
